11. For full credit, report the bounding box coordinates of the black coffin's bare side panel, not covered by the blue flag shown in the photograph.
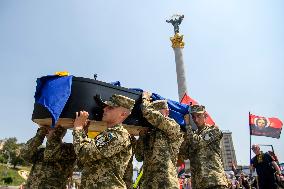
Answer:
[32,77,149,126]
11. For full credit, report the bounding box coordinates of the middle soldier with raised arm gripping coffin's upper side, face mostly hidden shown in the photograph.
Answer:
[135,92,183,189]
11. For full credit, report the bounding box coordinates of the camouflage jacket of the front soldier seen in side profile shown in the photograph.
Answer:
[73,125,132,189]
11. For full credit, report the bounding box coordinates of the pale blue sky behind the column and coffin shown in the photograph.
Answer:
[0,0,284,164]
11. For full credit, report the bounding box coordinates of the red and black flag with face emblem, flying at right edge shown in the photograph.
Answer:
[249,114,283,138]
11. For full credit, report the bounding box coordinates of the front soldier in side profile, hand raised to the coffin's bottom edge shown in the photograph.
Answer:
[73,94,135,189]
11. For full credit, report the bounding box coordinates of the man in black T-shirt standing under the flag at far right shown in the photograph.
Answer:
[251,144,281,189]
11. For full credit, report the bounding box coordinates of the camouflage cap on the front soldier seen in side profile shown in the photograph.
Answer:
[103,94,135,111]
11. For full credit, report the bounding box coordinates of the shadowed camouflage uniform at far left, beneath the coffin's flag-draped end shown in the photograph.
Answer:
[21,127,76,189]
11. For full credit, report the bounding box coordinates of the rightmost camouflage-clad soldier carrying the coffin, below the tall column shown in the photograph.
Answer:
[180,105,228,189]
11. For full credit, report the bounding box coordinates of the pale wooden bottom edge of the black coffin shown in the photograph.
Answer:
[33,118,147,136]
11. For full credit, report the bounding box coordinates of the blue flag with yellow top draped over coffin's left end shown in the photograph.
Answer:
[34,72,73,127]
